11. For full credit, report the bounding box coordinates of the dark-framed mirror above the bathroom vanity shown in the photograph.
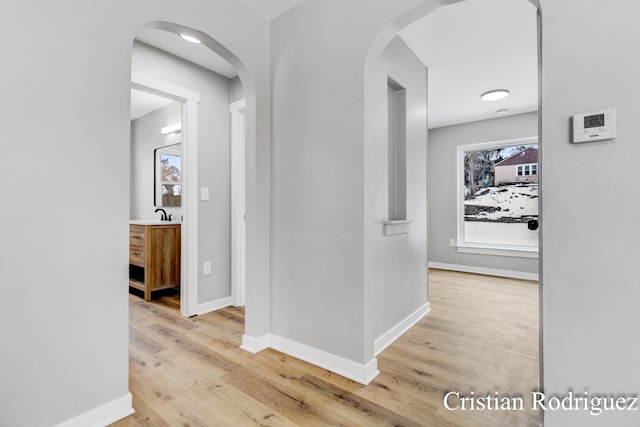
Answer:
[153,143,182,207]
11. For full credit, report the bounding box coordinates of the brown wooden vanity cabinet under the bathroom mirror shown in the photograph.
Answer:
[129,223,181,301]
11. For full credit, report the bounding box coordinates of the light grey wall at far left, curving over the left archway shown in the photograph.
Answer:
[0,0,270,426]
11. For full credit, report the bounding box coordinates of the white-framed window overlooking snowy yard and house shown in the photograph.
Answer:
[457,138,539,257]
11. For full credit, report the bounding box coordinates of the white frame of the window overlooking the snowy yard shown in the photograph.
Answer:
[456,136,539,258]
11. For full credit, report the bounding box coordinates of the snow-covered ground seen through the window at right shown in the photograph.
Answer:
[464,183,538,246]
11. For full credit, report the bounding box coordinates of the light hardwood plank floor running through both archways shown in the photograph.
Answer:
[112,270,538,427]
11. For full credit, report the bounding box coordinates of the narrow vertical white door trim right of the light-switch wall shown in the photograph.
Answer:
[229,99,247,307]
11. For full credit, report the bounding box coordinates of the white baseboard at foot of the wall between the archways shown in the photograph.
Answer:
[240,334,380,385]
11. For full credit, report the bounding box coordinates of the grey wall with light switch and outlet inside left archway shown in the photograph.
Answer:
[132,42,231,304]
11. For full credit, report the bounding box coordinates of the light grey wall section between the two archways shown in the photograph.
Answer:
[271,0,373,364]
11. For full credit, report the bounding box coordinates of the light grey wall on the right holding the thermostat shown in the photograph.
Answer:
[540,0,640,427]
